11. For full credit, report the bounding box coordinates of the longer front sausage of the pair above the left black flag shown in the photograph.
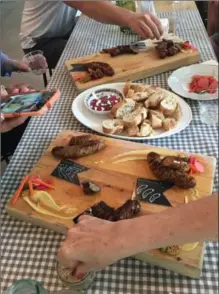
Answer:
[52,139,105,159]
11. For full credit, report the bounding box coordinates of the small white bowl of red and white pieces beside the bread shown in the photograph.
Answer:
[84,88,124,114]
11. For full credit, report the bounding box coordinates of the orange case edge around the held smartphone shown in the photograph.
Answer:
[4,89,61,118]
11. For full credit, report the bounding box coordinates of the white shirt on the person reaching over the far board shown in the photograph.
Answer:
[20,0,77,49]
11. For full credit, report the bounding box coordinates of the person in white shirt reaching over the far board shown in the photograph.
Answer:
[20,0,162,69]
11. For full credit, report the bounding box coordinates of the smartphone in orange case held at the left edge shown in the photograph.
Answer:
[1,89,60,118]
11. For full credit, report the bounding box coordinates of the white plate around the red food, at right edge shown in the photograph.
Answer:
[168,64,218,100]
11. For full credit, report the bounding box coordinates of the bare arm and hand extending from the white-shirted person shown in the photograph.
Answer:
[64,1,162,39]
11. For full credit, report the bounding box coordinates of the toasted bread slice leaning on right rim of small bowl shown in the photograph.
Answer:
[110,99,136,119]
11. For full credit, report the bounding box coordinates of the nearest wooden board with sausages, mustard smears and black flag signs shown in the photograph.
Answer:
[6,131,216,278]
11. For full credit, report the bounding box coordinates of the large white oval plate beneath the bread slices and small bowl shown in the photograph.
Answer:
[72,83,192,141]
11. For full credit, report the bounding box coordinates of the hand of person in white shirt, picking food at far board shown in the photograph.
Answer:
[128,12,163,40]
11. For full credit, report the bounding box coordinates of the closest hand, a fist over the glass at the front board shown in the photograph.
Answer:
[57,215,131,278]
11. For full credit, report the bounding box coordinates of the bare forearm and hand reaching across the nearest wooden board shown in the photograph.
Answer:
[58,194,218,277]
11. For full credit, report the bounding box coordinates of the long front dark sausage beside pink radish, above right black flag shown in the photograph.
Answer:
[147,152,196,189]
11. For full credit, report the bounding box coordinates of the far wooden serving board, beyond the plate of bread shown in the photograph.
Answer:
[65,49,200,92]
